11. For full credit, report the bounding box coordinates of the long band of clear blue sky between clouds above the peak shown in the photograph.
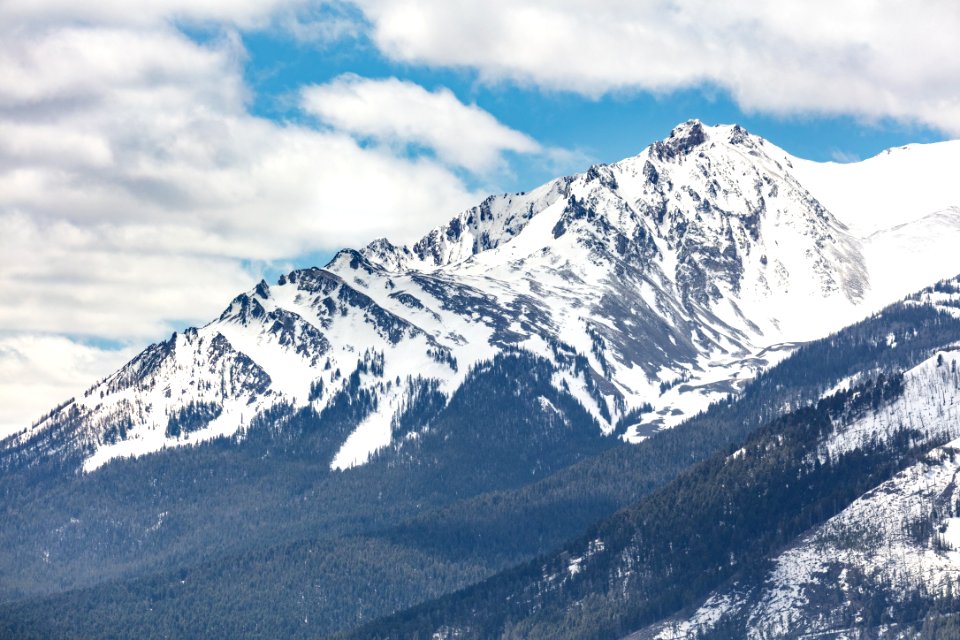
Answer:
[240,23,951,198]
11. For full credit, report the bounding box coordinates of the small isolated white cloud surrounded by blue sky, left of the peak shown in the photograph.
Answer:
[302,74,542,173]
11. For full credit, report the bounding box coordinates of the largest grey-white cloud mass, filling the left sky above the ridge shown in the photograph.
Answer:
[0,26,479,338]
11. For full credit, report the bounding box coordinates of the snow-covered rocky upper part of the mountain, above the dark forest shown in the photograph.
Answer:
[7,121,960,471]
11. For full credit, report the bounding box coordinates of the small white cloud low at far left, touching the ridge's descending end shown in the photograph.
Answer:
[0,334,137,439]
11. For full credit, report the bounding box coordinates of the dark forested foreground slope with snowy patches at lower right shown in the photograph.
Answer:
[349,279,960,640]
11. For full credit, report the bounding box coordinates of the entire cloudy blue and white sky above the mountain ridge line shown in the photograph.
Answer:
[0,0,960,435]
